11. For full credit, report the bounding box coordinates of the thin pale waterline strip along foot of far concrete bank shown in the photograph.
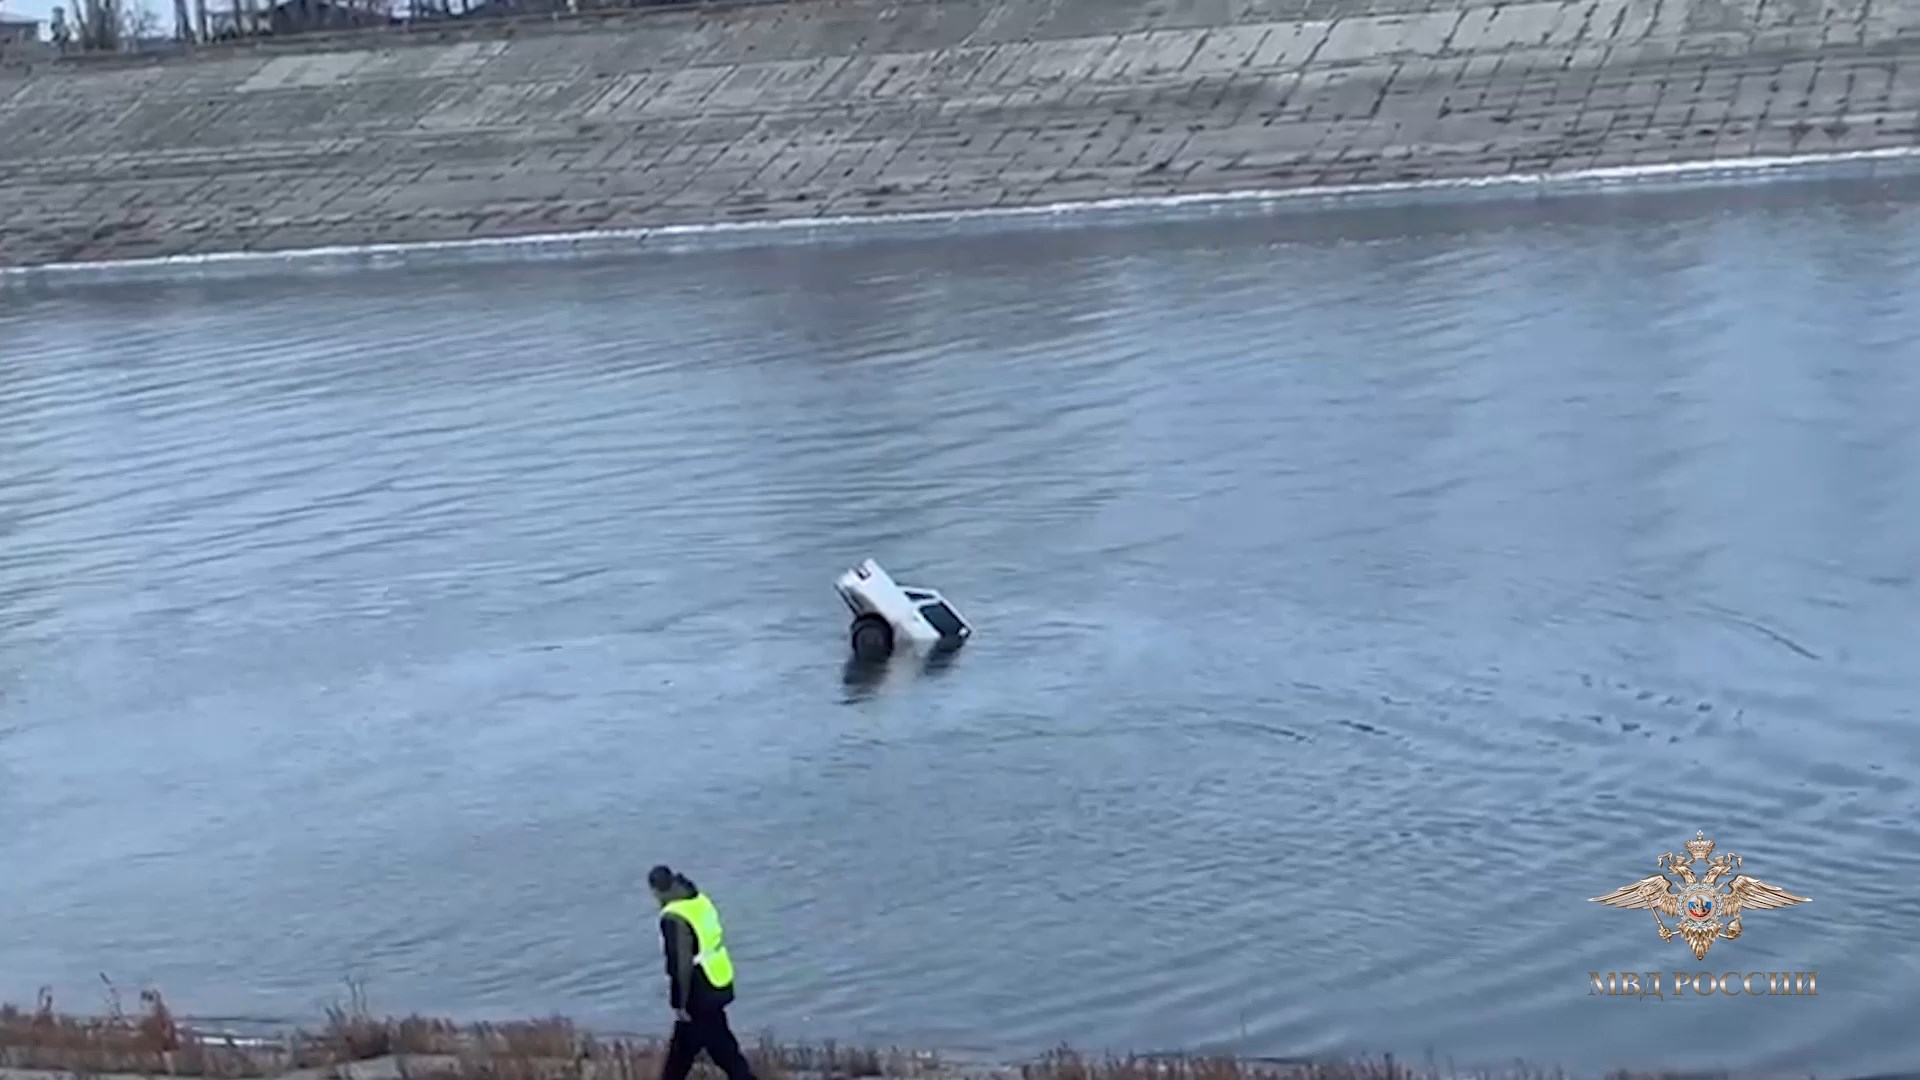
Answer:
[0,146,1920,288]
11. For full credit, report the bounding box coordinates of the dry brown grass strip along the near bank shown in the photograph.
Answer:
[0,984,1781,1080]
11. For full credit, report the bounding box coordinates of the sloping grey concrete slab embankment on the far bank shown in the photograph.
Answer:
[0,0,1920,265]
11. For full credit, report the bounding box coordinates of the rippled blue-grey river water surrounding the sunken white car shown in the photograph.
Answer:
[0,178,1920,1076]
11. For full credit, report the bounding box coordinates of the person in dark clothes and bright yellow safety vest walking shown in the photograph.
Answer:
[647,867,755,1080]
